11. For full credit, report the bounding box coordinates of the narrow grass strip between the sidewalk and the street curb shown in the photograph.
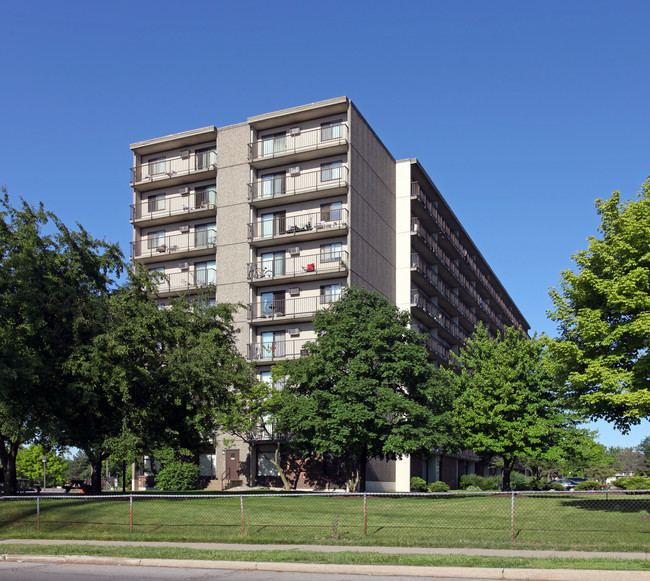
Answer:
[2,544,650,571]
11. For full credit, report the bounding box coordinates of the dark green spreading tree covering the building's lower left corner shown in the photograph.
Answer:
[66,266,252,491]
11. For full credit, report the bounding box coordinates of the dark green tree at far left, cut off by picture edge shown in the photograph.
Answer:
[0,193,122,493]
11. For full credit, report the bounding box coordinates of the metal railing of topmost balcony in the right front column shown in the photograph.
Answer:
[248,123,348,161]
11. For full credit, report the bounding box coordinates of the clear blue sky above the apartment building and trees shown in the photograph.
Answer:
[0,0,650,446]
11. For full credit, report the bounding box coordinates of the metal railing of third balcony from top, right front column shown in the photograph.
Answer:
[248,208,348,241]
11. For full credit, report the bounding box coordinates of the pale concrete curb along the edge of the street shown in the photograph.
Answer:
[0,554,650,581]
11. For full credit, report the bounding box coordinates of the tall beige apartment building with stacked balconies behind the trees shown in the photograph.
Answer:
[131,97,528,490]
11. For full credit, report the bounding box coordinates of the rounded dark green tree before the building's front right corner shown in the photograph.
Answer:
[273,287,452,490]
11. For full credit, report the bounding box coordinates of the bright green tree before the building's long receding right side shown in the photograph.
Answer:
[447,325,570,490]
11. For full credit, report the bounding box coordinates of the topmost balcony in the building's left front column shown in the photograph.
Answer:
[131,149,217,191]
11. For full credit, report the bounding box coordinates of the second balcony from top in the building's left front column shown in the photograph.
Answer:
[131,194,217,226]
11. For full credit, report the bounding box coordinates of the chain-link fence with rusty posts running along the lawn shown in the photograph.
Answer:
[0,491,650,551]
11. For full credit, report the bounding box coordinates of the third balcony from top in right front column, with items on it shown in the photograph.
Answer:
[248,208,348,246]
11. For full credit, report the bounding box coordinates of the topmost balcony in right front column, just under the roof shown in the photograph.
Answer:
[248,124,349,168]
